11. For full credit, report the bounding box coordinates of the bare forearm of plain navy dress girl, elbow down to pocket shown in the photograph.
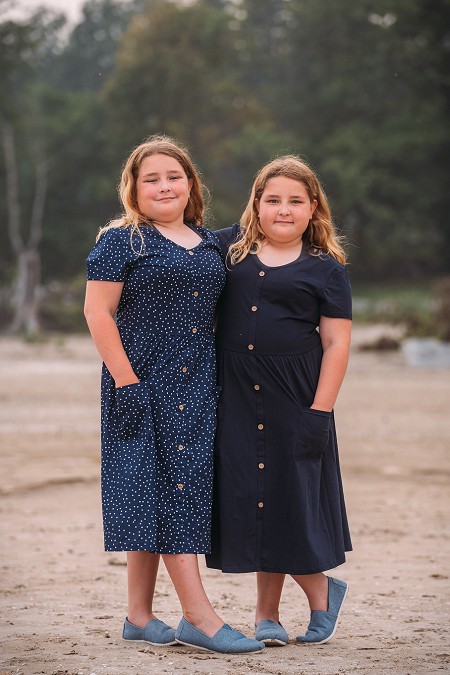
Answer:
[311,344,349,410]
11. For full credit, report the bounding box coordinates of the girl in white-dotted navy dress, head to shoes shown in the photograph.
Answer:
[85,136,264,652]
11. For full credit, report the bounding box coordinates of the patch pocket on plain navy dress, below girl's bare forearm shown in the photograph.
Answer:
[295,408,331,459]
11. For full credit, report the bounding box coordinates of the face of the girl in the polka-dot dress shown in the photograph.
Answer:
[136,155,192,225]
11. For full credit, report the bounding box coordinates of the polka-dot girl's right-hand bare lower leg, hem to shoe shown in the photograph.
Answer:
[163,553,224,637]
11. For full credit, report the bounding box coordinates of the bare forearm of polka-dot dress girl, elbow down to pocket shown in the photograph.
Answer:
[86,312,139,387]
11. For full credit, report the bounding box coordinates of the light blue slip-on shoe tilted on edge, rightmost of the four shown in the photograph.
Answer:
[296,577,348,645]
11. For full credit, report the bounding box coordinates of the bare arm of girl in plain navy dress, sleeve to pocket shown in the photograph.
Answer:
[311,316,352,411]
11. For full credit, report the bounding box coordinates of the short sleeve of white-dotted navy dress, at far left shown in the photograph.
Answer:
[86,228,137,281]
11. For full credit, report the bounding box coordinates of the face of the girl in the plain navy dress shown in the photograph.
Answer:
[256,176,317,245]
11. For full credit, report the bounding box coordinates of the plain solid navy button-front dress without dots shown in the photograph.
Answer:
[207,225,351,574]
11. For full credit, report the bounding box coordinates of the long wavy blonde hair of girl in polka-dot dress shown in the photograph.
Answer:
[97,134,205,247]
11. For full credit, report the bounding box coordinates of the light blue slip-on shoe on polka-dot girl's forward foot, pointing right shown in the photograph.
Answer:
[175,617,265,654]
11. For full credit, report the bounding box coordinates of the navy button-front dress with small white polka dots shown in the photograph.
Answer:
[87,226,225,553]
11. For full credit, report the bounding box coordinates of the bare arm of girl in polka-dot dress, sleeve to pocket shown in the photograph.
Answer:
[84,281,139,387]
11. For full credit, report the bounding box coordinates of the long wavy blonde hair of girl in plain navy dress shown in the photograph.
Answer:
[228,155,347,265]
